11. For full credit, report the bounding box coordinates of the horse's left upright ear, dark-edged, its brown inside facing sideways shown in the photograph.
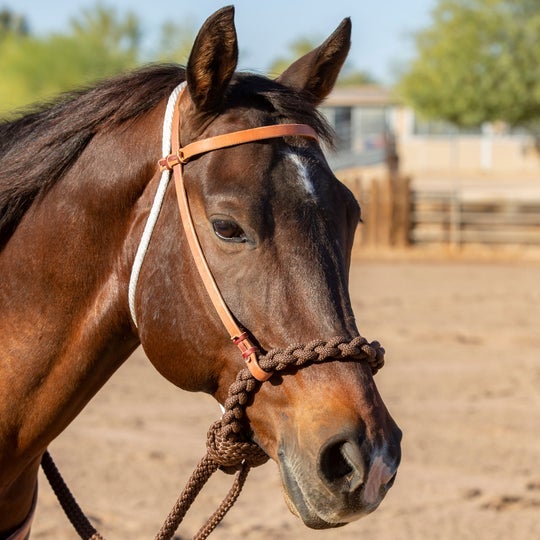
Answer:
[186,6,238,113]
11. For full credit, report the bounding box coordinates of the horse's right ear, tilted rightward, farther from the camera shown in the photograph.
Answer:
[277,18,352,105]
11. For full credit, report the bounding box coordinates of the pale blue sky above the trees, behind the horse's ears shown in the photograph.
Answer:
[0,0,436,84]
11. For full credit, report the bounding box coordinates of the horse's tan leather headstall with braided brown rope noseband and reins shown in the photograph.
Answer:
[42,85,384,540]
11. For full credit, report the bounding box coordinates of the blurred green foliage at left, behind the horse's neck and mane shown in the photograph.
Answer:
[0,4,194,115]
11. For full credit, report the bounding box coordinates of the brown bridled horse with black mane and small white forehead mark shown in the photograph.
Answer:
[0,7,401,538]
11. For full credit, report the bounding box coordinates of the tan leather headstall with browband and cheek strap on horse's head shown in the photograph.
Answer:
[159,86,318,382]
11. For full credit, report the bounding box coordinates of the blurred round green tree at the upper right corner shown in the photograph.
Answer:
[398,0,540,136]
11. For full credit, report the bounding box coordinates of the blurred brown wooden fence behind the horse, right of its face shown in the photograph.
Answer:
[341,175,540,251]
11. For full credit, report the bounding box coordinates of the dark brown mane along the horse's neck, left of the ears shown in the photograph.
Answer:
[0,65,185,245]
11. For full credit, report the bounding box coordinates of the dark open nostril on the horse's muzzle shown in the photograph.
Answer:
[319,439,364,493]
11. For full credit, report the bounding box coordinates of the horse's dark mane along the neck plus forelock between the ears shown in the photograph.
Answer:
[0,64,332,245]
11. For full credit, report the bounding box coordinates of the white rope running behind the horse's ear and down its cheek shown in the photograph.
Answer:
[128,82,186,326]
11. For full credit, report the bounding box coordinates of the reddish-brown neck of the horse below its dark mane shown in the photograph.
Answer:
[0,103,166,466]
